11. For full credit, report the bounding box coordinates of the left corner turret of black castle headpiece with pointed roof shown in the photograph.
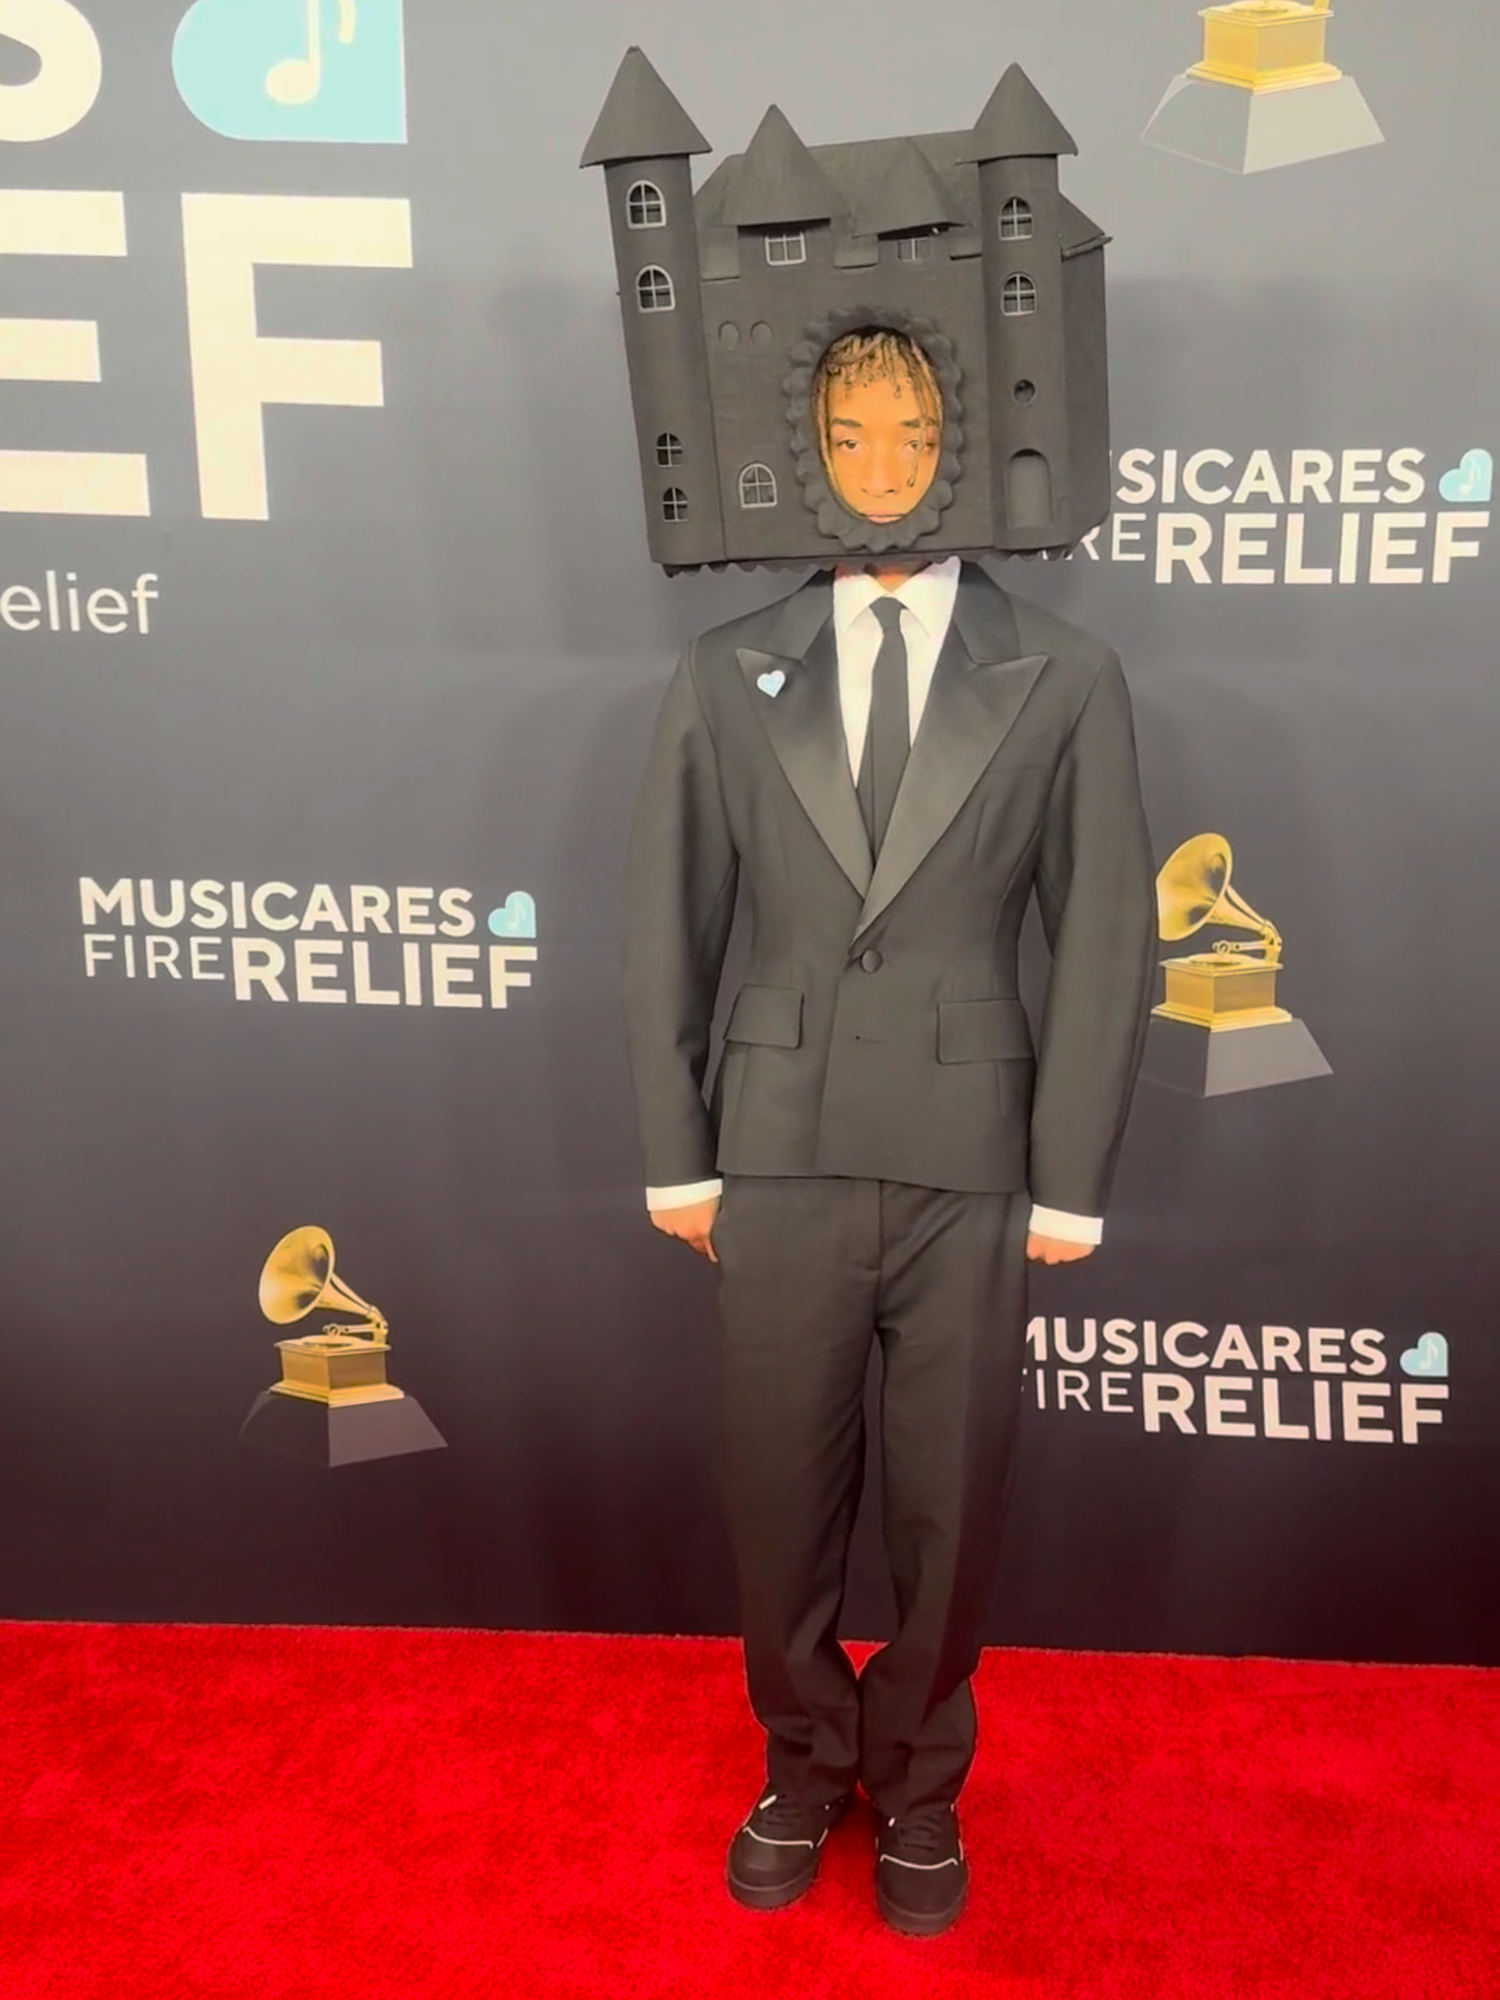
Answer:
[578,48,724,568]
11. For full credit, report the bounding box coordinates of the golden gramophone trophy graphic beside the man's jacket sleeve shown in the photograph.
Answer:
[1142,834,1330,1098]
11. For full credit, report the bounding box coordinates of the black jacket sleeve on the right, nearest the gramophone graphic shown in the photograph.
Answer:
[1030,654,1158,1216]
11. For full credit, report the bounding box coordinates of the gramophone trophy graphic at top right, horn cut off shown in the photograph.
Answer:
[1142,0,1384,174]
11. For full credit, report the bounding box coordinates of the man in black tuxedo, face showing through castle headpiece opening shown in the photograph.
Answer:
[626,328,1156,1934]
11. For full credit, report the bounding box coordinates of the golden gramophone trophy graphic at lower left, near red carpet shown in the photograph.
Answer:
[240,1228,446,1466]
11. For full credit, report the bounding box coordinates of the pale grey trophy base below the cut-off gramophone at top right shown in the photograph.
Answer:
[1142,72,1384,174]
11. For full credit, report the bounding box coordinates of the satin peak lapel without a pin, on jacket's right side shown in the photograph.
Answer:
[854,572,1046,938]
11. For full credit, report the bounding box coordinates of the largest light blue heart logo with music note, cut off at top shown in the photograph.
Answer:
[172,0,406,146]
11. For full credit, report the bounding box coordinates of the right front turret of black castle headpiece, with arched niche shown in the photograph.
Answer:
[964,64,1078,550]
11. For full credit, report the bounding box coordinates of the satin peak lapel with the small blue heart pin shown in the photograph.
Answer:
[736,616,872,896]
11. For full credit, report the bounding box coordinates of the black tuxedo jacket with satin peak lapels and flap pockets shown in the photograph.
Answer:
[624,564,1156,1214]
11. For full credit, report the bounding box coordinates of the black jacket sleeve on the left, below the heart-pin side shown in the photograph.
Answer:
[624,646,738,1188]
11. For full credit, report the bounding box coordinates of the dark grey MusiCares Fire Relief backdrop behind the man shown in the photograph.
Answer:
[0,0,1500,1662]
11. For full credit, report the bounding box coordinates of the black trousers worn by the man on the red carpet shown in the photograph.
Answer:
[714,1176,1030,1816]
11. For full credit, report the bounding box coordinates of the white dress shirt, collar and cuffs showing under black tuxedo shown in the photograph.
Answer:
[646,556,1104,1244]
